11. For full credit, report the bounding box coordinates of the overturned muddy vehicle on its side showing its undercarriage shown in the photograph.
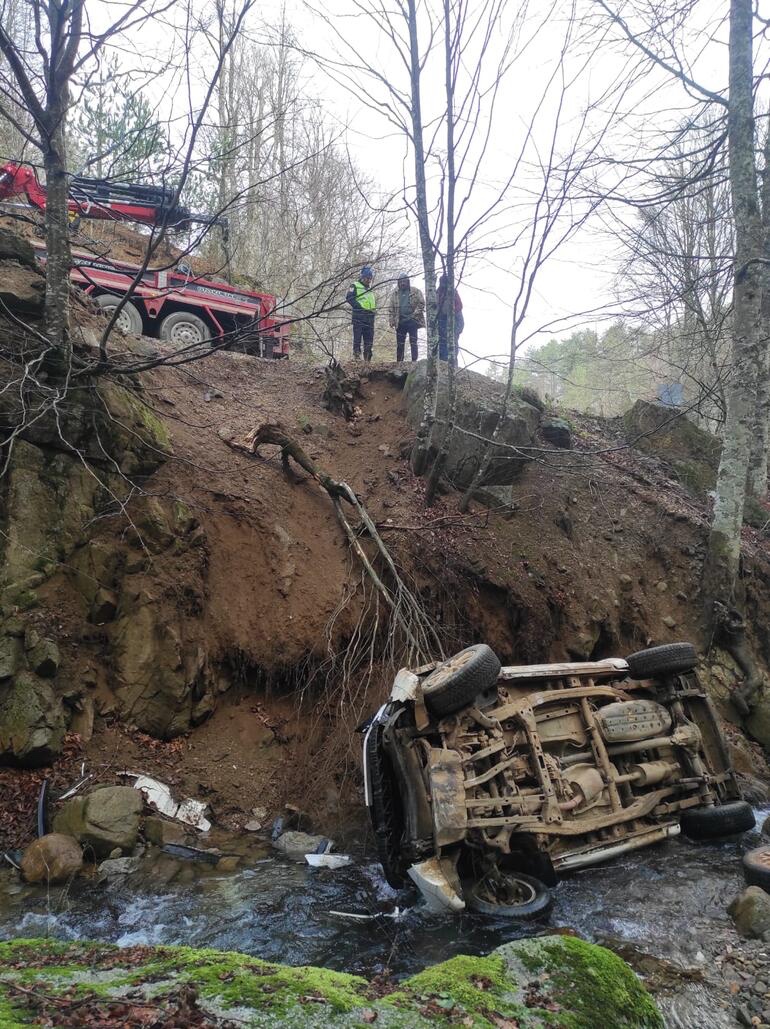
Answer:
[362,643,755,918]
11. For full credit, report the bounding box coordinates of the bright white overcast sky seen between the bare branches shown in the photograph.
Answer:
[81,0,741,361]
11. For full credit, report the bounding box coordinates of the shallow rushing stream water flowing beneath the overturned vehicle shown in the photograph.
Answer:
[0,812,767,1029]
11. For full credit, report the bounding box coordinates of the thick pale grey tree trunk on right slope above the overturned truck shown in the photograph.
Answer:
[703,0,763,605]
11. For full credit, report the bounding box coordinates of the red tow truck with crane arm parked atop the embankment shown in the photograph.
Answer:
[0,163,289,357]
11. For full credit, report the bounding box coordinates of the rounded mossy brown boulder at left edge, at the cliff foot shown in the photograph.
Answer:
[0,671,66,768]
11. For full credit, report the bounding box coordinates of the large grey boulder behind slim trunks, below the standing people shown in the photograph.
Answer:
[405,361,540,489]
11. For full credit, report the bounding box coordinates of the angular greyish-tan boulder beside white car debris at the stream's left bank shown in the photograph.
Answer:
[54,786,142,859]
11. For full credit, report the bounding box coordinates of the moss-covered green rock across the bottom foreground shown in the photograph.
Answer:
[0,936,663,1029]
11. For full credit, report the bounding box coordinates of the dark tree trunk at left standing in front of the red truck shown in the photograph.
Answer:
[43,115,72,354]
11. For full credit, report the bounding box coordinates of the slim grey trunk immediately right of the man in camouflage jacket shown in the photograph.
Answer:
[408,0,439,475]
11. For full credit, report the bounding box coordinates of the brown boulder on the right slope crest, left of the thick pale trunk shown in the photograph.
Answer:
[623,400,722,496]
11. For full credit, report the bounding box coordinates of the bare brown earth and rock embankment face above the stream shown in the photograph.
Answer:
[0,244,770,839]
